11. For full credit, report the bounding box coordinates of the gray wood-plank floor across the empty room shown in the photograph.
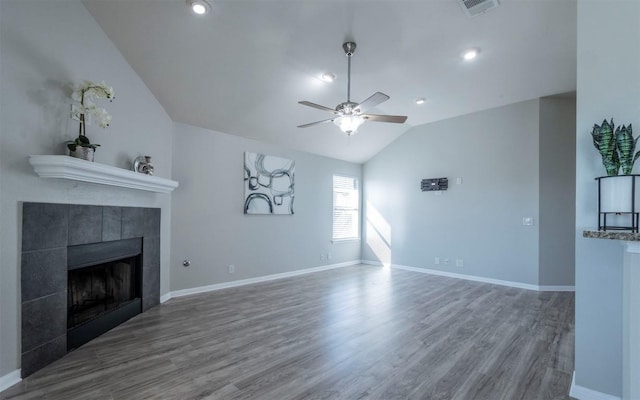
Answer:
[0,265,574,400]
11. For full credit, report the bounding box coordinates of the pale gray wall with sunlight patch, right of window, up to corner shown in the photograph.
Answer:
[363,100,539,285]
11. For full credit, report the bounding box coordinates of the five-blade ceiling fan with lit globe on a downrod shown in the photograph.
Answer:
[298,42,407,136]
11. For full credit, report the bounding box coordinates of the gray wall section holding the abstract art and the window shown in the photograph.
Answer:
[171,123,362,290]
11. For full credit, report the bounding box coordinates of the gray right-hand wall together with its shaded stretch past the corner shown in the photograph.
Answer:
[362,98,575,290]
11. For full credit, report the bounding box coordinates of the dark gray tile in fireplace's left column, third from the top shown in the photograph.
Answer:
[22,289,67,353]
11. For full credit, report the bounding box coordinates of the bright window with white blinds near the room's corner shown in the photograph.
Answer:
[332,175,360,240]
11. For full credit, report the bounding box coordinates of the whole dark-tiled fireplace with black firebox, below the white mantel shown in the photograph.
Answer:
[21,203,160,377]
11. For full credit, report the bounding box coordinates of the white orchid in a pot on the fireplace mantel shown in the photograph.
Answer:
[67,81,114,151]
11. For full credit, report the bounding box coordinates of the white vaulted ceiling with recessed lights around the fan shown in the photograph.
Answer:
[84,0,576,163]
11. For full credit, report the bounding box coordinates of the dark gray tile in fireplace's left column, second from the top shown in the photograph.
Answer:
[20,247,67,302]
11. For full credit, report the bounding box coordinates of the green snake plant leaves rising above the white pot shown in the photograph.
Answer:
[591,119,640,176]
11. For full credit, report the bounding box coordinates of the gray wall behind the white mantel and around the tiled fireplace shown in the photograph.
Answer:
[0,1,173,377]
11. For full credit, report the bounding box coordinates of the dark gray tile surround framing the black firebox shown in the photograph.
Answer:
[21,205,160,376]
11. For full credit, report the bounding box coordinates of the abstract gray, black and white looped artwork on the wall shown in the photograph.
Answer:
[244,152,295,214]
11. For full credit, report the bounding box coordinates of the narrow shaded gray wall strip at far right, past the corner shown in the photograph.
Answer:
[538,96,576,286]
